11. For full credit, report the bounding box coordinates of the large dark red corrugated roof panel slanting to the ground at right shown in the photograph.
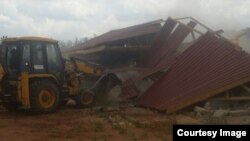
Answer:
[138,33,250,112]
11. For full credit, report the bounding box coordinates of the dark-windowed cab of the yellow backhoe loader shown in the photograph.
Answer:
[1,37,64,80]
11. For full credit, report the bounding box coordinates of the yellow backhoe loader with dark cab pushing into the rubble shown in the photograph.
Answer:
[0,37,102,113]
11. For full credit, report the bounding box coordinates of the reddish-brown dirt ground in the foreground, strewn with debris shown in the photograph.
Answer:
[0,106,250,141]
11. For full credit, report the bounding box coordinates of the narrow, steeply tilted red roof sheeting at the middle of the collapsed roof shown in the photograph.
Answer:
[146,18,196,68]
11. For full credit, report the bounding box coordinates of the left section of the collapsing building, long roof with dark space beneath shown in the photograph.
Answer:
[62,20,163,68]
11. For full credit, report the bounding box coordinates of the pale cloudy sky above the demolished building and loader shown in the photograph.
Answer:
[0,0,250,41]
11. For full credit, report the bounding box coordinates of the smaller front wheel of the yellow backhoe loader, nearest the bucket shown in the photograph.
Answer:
[74,89,95,108]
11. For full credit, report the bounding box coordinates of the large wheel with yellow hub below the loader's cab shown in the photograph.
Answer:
[30,80,59,113]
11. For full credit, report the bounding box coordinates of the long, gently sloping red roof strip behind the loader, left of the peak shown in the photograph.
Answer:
[63,20,163,52]
